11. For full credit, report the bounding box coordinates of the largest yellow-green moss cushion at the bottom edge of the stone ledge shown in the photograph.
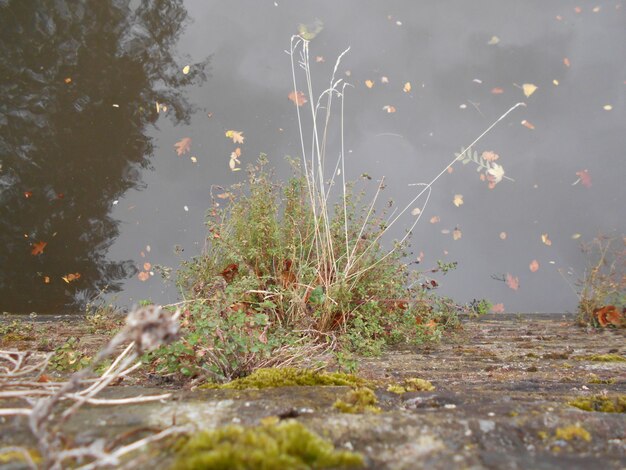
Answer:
[172,421,363,470]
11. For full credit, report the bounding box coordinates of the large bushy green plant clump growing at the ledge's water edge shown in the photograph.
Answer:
[148,156,458,382]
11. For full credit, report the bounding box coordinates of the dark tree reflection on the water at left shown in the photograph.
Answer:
[0,0,208,312]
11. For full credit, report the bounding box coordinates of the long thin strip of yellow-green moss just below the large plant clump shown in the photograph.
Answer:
[202,368,366,390]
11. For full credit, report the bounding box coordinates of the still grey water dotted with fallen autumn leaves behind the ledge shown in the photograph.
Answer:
[0,0,626,313]
